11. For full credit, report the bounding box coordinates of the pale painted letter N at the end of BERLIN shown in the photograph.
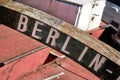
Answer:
[89,54,107,72]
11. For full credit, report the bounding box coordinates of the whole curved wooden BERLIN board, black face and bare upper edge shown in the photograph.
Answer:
[0,1,120,80]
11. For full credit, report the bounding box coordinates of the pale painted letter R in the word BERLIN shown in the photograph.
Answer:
[46,28,60,46]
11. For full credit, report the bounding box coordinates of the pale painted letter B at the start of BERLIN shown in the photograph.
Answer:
[17,14,28,32]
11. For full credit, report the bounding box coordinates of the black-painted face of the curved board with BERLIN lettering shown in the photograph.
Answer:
[0,7,120,80]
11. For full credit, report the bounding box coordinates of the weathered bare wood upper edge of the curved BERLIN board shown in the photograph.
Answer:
[3,1,120,66]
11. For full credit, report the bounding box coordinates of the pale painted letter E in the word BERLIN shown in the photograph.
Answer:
[32,21,44,39]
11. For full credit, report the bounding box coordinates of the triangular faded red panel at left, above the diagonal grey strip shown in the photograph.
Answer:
[0,25,43,62]
